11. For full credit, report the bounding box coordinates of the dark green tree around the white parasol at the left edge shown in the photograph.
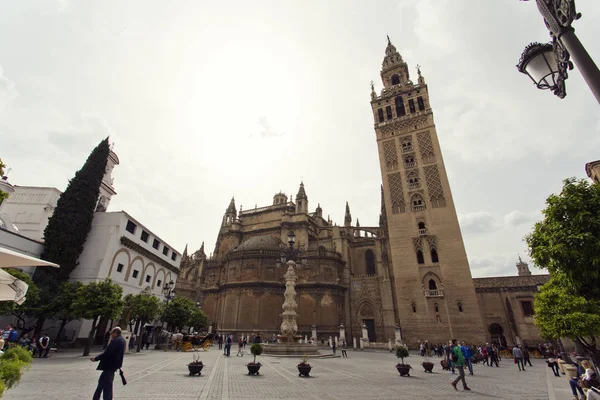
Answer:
[0,268,40,334]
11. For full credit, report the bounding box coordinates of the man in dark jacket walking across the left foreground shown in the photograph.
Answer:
[90,326,125,400]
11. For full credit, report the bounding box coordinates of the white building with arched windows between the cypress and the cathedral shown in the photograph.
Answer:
[68,211,181,339]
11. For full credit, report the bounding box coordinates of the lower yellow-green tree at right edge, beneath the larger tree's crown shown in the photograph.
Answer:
[534,276,600,363]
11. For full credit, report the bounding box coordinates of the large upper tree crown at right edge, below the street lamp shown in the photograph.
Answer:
[525,178,600,299]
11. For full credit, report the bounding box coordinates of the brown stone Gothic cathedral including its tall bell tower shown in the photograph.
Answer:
[177,38,543,345]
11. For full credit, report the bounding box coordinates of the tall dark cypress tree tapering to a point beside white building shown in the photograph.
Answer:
[36,138,110,286]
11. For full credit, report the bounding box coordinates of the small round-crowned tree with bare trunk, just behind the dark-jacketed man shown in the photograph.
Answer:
[73,279,124,356]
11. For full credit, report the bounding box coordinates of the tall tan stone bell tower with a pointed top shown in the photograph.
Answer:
[371,37,485,344]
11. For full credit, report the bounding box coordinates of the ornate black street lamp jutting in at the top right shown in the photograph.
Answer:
[517,0,600,103]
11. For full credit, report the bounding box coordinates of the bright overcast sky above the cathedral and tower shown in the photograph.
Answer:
[0,0,600,277]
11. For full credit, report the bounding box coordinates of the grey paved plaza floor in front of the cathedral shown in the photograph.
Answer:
[5,346,571,400]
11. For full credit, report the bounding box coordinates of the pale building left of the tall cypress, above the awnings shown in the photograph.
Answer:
[0,185,62,241]
